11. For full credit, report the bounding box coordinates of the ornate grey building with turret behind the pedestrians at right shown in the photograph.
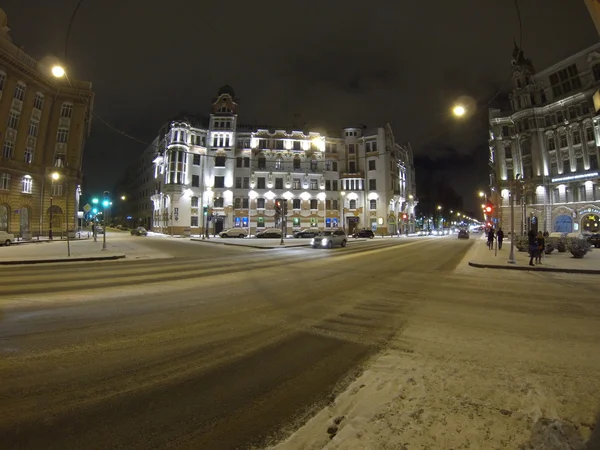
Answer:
[489,43,600,233]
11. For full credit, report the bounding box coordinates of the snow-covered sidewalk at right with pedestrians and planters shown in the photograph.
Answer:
[468,237,600,274]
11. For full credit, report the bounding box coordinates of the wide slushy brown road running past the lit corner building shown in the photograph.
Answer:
[0,237,596,450]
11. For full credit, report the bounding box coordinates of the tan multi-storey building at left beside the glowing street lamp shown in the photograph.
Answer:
[0,9,94,238]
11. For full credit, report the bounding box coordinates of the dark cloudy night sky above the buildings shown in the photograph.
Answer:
[0,0,598,214]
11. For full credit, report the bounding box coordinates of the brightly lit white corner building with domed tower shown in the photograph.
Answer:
[152,86,416,235]
